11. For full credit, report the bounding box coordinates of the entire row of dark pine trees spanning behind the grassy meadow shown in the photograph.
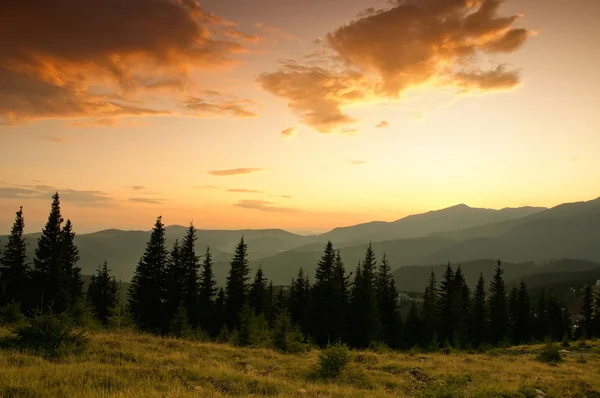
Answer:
[0,193,600,349]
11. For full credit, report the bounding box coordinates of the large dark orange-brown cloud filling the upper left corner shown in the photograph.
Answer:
[0,0,246,124]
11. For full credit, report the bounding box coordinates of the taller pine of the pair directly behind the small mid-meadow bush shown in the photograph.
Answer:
[310,241,338,346]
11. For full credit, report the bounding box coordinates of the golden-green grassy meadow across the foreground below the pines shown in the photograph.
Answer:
[0,329,600,398]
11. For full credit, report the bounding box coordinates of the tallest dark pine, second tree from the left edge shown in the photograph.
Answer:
[32,192,68,313]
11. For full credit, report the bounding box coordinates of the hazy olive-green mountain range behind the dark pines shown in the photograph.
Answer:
[0,198,600,291]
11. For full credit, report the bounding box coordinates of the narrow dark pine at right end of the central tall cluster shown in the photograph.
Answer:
[375,253,402,348]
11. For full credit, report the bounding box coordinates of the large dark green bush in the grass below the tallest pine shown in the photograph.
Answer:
[13,313,88,359]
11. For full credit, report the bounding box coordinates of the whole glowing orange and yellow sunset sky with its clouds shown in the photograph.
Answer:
[0,0,600,233]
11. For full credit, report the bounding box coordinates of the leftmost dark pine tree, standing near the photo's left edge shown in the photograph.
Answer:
[0,207,30,308]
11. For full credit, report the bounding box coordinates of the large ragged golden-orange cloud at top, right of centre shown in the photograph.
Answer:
[258,0,533,133]
